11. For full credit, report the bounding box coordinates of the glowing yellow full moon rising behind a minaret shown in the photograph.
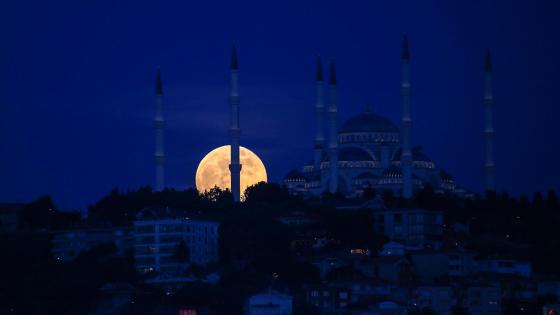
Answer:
[196,145,266,196]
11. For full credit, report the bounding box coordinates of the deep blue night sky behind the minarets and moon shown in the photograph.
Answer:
[0,0,560,209]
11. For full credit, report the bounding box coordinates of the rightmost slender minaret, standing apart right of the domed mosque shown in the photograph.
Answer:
[484,49,496,191]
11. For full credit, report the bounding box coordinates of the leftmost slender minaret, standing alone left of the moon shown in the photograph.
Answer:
[154,66,165,191]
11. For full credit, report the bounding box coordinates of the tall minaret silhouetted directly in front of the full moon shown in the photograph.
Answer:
[229,46,241,202]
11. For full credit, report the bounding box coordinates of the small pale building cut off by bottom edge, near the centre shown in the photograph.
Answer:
[246,291,292,315]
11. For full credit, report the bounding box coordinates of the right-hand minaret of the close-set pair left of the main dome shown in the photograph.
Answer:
[328,60,338,194]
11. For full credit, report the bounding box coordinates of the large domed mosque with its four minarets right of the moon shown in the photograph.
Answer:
[284,36,494,198]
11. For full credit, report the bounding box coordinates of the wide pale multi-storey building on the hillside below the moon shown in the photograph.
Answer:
[134,209,219,273]
